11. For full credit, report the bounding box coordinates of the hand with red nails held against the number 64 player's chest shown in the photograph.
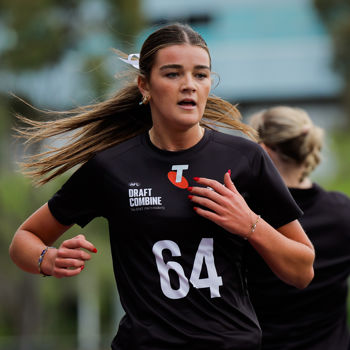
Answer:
[188,172,257,237]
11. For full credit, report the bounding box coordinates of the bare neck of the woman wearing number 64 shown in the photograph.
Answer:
[148,124,204,151]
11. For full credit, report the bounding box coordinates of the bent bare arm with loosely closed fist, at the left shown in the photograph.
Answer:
[10,204,97,278]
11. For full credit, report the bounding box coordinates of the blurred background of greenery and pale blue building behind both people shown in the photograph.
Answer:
[0,0,350,350]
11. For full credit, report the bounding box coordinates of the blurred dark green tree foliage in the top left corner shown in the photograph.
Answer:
[0,0,142,71]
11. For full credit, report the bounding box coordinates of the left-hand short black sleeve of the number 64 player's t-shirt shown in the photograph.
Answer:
[48,159,103,227]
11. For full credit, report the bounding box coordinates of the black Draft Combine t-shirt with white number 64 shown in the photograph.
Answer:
[49,130,301,350]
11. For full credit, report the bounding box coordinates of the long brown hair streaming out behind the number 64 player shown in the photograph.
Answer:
[15,23,255,185]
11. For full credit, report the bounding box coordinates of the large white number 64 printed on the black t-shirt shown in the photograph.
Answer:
[152,238,222,299]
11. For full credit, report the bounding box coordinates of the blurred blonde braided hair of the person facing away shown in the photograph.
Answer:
[249,106,324,182]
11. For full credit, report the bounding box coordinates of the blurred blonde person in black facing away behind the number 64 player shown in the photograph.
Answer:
[248,106,350,350]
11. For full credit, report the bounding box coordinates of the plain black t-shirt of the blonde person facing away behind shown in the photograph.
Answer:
[248,184,350,350]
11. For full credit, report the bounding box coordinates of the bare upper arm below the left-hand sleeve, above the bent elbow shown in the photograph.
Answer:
[17,203,71,245]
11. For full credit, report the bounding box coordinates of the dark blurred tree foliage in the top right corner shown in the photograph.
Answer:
[314,0,350,119]
